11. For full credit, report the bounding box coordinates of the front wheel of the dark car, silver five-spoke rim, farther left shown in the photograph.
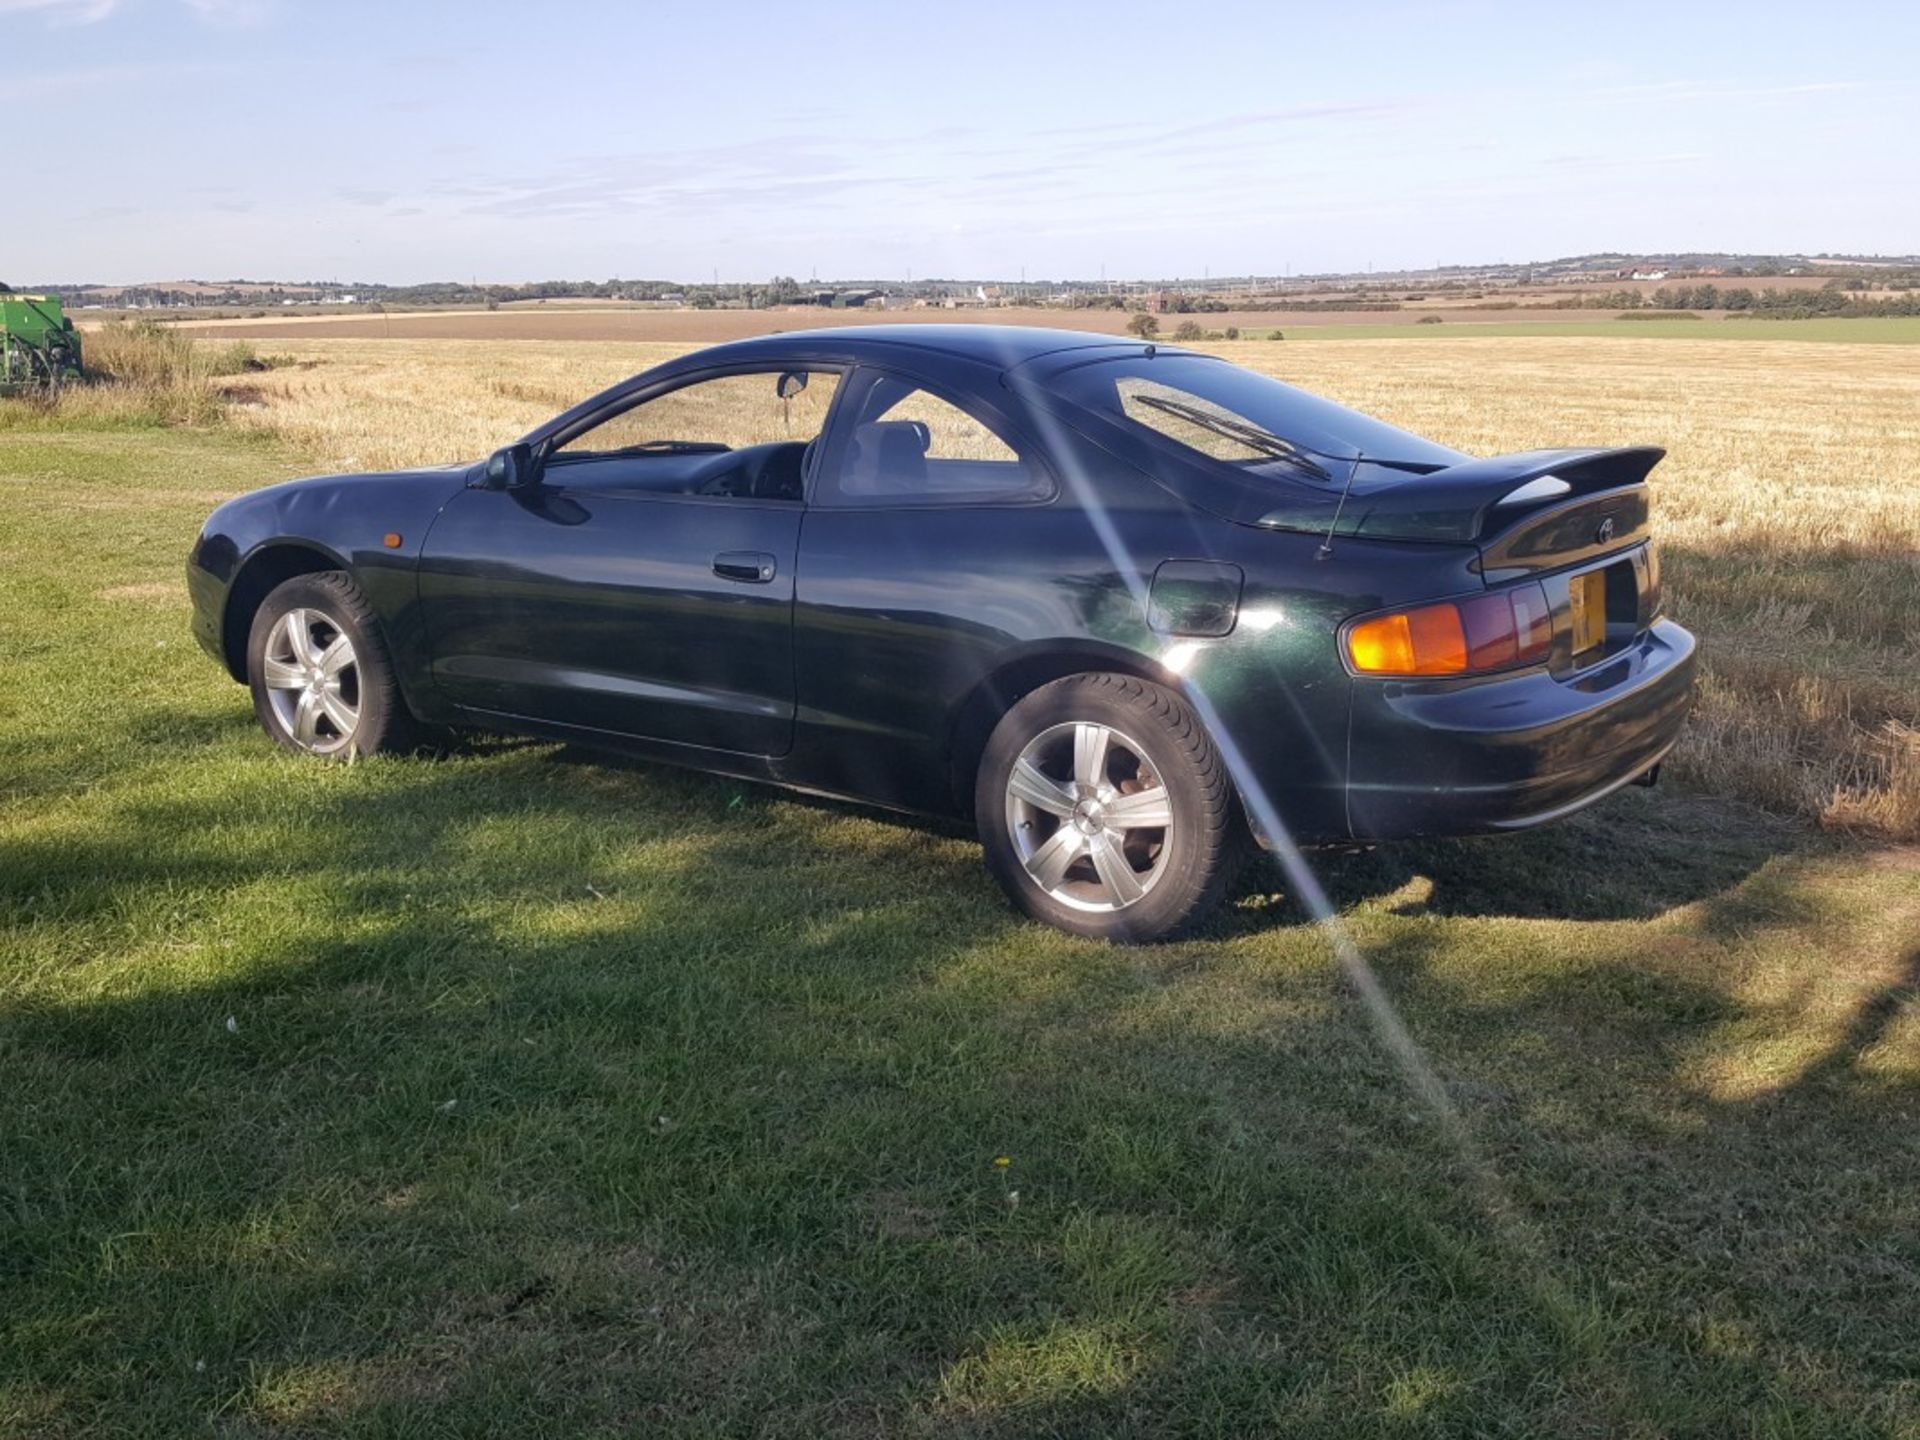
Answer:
[246,570,419,760]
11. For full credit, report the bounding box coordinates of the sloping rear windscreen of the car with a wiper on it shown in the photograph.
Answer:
[1052,355,1459,480]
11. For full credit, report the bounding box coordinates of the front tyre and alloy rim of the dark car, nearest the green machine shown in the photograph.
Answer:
[246,570,422,760]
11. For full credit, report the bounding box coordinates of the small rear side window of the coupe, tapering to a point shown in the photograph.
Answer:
[820,372,1048,505]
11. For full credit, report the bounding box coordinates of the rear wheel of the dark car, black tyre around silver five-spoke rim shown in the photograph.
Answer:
[973,674,1246,943]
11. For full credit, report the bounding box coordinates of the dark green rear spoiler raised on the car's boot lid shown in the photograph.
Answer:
[1258,445,1667,545]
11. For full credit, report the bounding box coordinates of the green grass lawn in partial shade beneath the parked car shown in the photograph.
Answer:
[0,426,1920,1438]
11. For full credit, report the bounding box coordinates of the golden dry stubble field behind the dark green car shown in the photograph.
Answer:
[214,338,1920,839]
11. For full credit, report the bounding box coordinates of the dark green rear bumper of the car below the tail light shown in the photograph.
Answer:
[1348,620,1693,839]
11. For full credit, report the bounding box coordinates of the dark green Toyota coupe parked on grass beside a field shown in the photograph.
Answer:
[188,324,1693,941]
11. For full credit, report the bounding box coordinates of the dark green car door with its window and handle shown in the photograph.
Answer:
[420,371,837,755]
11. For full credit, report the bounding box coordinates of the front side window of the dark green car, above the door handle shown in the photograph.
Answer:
[547,371,839,501]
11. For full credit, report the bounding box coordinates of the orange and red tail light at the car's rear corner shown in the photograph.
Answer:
[1346,582,1553,676]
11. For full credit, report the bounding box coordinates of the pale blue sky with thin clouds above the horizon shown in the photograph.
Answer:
[15,0,1920,284]
